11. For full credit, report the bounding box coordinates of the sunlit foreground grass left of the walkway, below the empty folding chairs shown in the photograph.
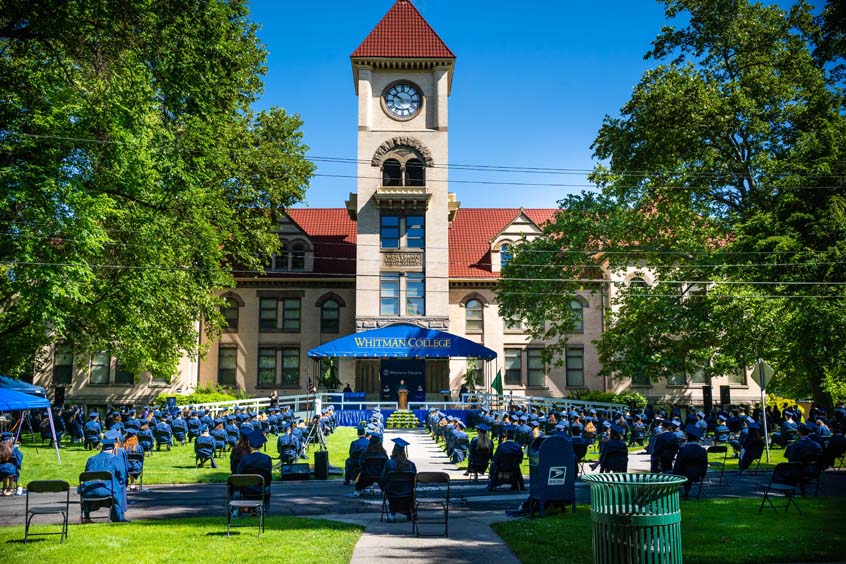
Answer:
[0,516,363,564]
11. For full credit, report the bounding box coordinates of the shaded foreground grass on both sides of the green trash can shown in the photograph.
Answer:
[493,497,846,564]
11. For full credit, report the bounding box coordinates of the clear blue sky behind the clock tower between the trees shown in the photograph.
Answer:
[251,0,808,207]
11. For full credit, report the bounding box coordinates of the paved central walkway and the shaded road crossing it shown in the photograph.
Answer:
[0,430,846,564]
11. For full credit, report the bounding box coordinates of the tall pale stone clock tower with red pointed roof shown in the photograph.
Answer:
[347,0,458,331]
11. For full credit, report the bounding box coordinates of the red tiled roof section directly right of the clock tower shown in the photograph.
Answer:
[449,208,558,278]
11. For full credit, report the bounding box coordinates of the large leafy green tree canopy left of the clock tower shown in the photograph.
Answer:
[0,0,312,377]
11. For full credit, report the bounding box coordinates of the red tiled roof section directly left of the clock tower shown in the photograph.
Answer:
[286,208,356,276]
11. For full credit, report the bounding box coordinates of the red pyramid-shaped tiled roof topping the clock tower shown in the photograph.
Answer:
[350,0,455,59]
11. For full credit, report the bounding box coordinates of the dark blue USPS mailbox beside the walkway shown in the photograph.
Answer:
[529,436,576,517]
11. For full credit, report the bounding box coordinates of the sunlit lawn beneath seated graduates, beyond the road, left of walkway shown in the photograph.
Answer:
[13,427,356,486]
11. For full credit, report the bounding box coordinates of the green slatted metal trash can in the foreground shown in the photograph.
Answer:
[582,473,686,564]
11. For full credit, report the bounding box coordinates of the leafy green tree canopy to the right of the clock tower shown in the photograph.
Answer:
[499,0,846,406]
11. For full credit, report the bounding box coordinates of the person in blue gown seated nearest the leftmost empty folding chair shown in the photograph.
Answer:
[77,431,127,522]
